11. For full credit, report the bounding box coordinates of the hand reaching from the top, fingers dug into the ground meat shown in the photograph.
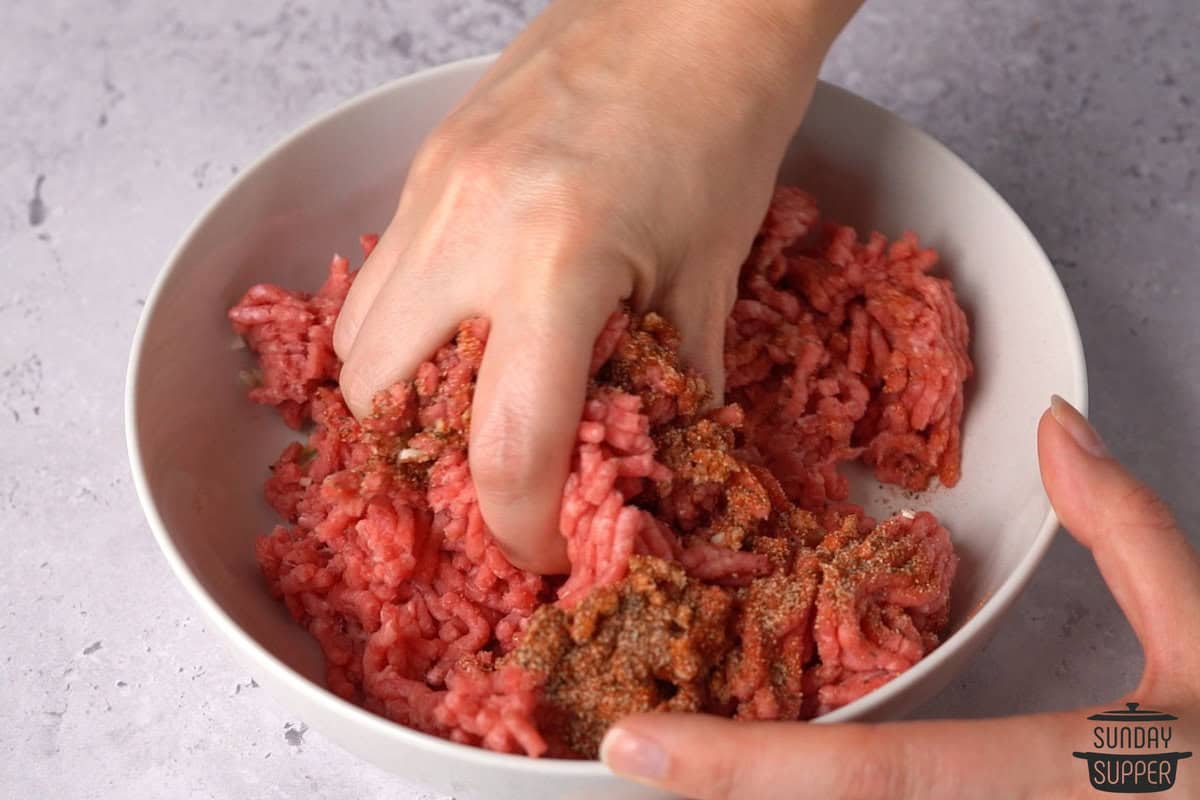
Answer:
[334,0,859,572]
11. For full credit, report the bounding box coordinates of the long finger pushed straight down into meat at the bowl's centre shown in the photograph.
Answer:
[469,277,619,573]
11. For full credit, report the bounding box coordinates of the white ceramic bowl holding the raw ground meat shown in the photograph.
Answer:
[126,53,1086,800]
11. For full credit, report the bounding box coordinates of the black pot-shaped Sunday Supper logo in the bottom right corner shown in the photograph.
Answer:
[1073,703,1192,794]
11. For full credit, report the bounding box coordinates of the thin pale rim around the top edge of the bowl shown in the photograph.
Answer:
[125,54,1087,778]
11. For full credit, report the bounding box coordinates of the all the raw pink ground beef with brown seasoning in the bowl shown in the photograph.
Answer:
[229,188,971,757]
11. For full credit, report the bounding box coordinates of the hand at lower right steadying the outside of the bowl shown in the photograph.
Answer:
[601,398,1200,800]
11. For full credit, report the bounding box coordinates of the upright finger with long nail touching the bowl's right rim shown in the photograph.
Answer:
[1038,397,1200,691]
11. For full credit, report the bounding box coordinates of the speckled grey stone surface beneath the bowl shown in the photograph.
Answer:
[0,0,1200,798]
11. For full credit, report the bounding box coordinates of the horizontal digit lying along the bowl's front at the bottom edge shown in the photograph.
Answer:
[600,712,1087,800]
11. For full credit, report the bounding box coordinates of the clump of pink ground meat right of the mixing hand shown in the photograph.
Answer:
[725,188,972,510]
